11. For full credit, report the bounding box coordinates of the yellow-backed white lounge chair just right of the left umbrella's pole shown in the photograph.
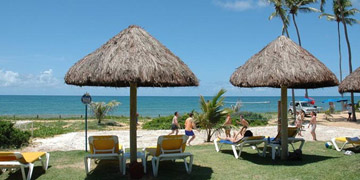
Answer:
[144,135,194,177]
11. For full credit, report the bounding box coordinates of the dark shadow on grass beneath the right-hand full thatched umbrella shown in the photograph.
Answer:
[221,150,337,166]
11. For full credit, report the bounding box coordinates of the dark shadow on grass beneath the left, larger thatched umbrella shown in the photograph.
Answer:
[85,160,213,180]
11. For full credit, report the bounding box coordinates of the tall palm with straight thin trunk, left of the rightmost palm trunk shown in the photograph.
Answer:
[319,0,359,111]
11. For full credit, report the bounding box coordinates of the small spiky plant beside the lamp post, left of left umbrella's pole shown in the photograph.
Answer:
[90,100,121,124]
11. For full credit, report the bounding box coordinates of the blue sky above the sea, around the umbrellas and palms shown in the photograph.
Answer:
[0,0,360,96]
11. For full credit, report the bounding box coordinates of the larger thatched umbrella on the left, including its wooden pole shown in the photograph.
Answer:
[65,25,199,162]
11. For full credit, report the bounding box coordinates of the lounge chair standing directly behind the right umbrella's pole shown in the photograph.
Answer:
[267,127,305,159]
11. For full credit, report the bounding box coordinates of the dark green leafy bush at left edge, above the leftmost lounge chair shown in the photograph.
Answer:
[0,121,31,149]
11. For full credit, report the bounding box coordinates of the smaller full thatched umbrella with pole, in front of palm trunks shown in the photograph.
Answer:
[230,36,338,159]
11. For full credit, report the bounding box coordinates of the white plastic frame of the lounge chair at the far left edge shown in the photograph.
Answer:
[0,152,50,180]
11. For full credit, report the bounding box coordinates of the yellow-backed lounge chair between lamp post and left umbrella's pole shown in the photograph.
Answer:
[84,136,125,174]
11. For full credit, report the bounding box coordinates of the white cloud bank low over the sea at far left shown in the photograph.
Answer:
[0,69,60,87]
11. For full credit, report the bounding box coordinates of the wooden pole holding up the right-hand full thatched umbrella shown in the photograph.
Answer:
[281,86,288,160]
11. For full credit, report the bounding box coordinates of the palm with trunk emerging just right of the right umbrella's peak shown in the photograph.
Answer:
[285,0,321,97]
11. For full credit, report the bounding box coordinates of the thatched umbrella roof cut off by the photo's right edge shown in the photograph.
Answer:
[339,67,360,93]
